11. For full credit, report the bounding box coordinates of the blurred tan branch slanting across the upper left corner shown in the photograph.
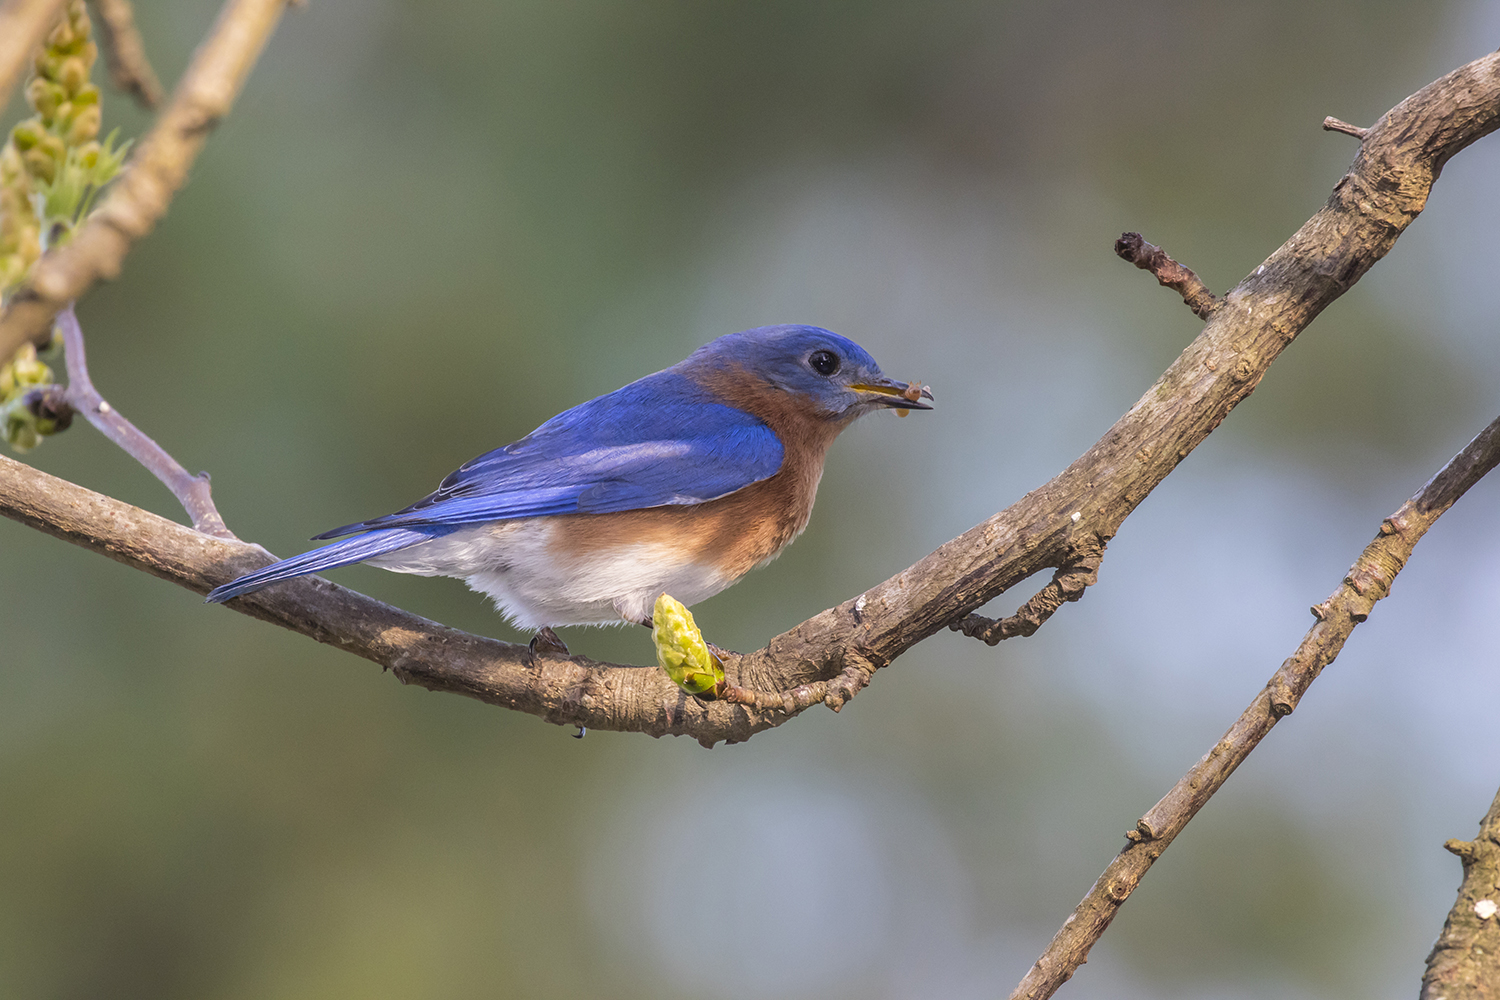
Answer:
[0,0,288,358]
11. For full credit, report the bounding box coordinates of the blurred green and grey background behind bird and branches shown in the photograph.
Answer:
[0,0,1500,1000]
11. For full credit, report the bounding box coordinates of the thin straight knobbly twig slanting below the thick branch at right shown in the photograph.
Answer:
[1011,418,1500,1000]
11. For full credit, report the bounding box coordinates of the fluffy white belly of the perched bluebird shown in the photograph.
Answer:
[369,517,737,630]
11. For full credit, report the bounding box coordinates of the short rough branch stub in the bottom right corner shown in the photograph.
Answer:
[1422,785,1500,1000]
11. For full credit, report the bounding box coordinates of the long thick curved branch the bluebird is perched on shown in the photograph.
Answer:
[0,54,1500,744]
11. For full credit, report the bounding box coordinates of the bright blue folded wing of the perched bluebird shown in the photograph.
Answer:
[318,372,783,538]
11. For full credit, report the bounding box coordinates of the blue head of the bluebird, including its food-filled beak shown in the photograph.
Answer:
[680,325,933,420]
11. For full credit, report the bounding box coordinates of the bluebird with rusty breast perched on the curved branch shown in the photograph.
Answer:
[199,325,933,651]
